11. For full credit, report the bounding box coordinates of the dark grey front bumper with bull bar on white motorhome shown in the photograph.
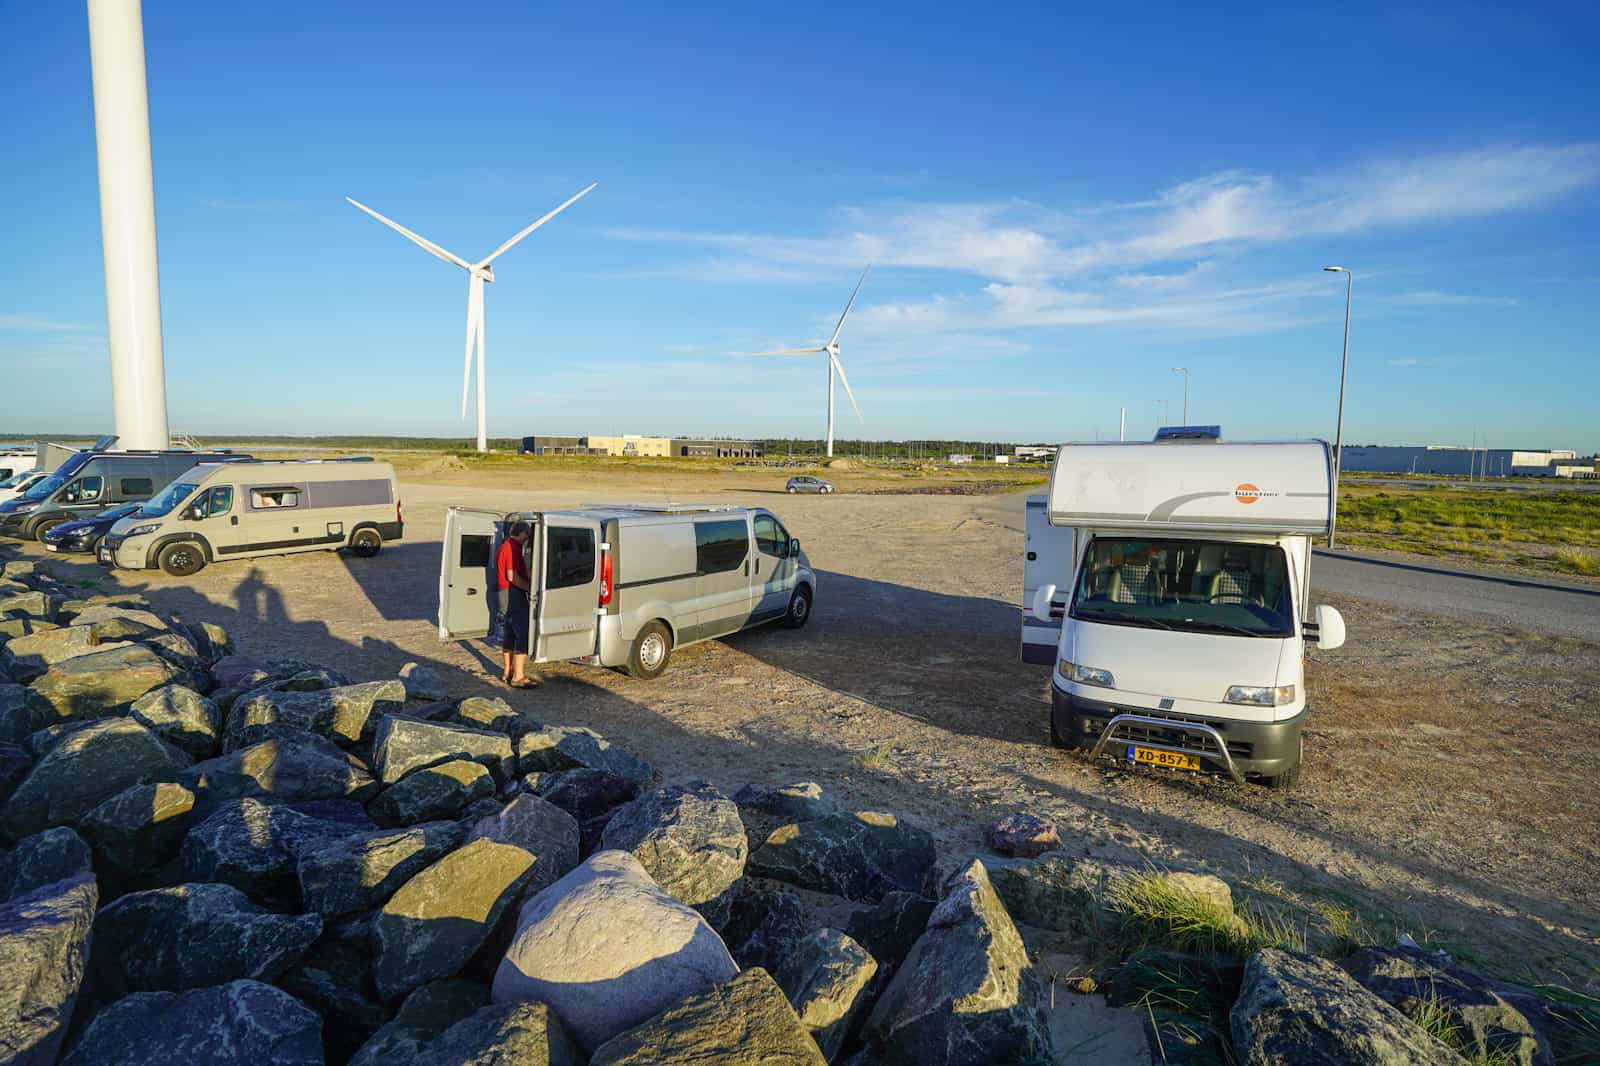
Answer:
[1050,685,1306,778]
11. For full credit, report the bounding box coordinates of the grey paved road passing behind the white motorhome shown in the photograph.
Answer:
[974,493,1600,640]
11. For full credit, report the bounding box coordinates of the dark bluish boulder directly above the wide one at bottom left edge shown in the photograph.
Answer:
[93,885,322,999]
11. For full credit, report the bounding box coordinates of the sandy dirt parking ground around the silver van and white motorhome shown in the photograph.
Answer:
[29,461,1600,994]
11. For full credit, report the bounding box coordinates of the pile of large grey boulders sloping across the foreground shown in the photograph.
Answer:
[0,550,1574,1066]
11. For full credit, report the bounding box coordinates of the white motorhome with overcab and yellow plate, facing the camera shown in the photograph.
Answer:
[1022,429,1344,787]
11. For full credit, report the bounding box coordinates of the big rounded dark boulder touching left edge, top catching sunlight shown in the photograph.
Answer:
[0,719,189,839]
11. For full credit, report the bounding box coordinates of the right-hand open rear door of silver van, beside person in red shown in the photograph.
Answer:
[533,515,602,663]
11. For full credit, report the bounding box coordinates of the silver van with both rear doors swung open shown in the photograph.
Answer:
[438,504,816,679]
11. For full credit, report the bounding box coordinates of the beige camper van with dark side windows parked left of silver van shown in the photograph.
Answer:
[99,456,405,578]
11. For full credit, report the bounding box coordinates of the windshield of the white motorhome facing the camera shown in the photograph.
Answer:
[1072,536,1294,637]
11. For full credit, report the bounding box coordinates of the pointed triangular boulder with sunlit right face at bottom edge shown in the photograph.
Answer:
[867,861,1051,1066]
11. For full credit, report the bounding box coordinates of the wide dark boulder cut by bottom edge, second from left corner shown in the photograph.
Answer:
[61,981,323,1066]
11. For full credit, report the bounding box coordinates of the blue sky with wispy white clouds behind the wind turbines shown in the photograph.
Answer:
[0,0,1600,451]
